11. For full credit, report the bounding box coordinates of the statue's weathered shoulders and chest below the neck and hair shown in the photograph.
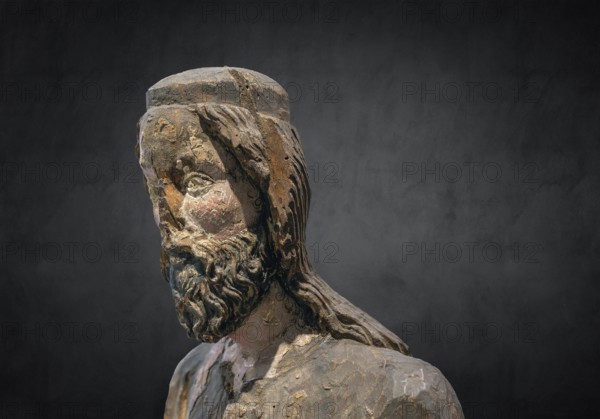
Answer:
[165,335,463,419]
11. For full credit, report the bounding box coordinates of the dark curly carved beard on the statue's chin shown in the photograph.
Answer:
[161,230,270,342]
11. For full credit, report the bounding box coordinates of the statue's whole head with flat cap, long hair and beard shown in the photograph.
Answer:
[138,67,408,353]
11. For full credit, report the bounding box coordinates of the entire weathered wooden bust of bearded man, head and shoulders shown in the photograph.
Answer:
[138,67,463,419]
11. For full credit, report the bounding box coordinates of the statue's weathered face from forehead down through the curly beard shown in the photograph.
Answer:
[139,107,268,342]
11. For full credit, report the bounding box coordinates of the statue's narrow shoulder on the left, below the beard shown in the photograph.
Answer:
[164,342,224,419]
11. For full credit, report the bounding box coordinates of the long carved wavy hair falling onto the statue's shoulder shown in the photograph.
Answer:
[188,69,409,355]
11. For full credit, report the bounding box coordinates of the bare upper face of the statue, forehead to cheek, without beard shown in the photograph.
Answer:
[140,108,260,238]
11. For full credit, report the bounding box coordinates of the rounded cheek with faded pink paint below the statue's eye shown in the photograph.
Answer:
[181,182,247,235]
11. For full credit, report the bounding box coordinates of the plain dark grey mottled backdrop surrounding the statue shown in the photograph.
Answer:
[0,0,600,418]
